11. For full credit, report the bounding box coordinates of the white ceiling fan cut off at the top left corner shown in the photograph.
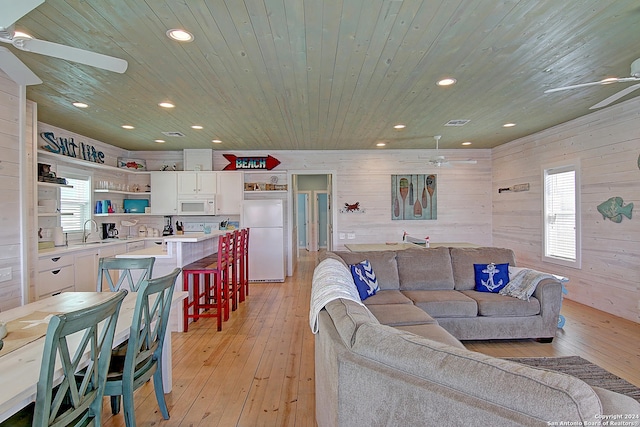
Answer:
[0,0,128,84]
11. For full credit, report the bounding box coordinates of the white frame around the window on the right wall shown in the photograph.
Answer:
[542,159,582,269]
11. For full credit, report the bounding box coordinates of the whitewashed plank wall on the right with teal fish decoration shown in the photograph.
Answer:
[492,98,640,322]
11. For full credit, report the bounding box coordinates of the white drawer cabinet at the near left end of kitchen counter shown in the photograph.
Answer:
[36,255,75,299]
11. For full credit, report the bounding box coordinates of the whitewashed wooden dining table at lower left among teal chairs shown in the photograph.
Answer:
[0,290,187,422]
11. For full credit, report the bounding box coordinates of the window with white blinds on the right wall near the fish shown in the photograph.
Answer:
[543,165,580,268]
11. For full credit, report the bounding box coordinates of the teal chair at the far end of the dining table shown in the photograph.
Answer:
[96,257,156,292]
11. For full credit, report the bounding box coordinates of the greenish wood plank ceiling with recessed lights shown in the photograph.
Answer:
[0,0,640,150]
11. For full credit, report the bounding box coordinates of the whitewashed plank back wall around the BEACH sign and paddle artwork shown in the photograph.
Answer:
[214,149,491,249]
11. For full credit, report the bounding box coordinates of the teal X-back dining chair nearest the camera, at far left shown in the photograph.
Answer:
[1,290,127,427]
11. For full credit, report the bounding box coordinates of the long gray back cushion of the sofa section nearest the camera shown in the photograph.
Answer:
[352,324,603,425]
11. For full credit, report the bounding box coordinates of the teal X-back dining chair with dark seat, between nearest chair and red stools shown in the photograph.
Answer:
[104,268,181,427]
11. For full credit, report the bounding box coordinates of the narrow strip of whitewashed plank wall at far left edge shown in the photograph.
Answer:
[0,71,22,310]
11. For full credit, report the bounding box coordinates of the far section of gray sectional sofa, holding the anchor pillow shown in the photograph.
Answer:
[326,247,562,342]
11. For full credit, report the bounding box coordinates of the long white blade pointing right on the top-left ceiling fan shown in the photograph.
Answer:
[13,38,129,73]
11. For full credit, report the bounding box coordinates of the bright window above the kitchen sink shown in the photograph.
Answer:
[58,168,91,233]
